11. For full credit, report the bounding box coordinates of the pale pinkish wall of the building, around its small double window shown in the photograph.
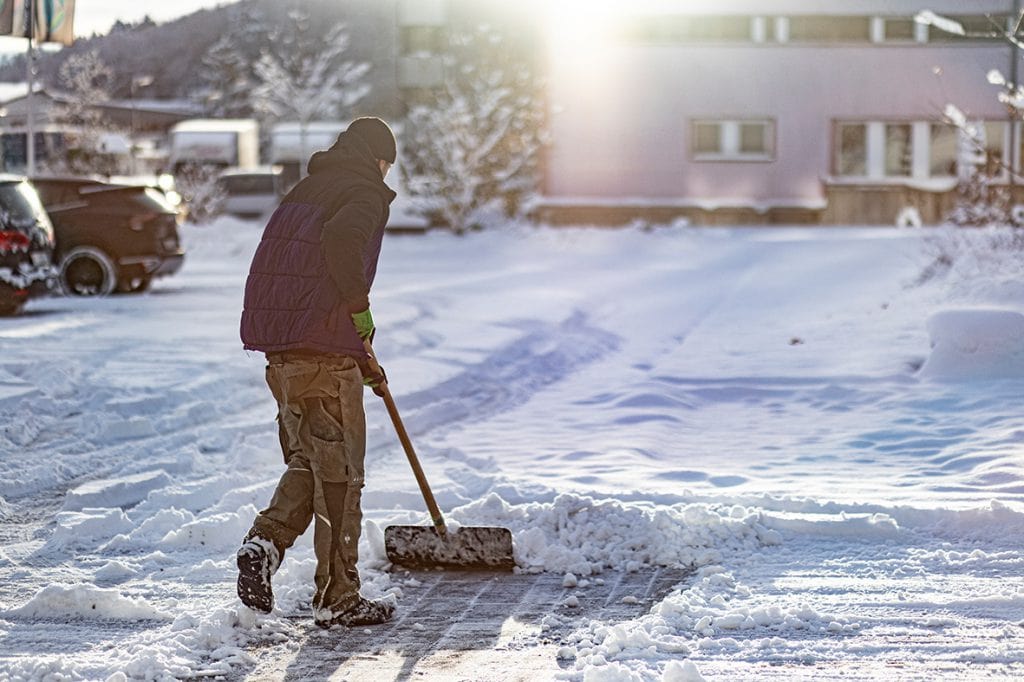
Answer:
[546,45,1010,203]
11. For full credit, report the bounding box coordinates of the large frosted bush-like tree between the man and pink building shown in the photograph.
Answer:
[400,26,546,232]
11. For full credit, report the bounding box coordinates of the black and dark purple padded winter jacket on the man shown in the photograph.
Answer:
[241,133,395,357]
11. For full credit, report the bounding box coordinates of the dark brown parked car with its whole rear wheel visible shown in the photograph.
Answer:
[33,178,184,296]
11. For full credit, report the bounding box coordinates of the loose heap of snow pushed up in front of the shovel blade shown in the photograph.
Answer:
[453,494,779,576]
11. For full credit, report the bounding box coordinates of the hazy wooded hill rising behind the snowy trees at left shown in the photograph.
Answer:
[0,0,399,116]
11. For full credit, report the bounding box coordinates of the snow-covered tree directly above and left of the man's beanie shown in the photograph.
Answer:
[251,9,371,174]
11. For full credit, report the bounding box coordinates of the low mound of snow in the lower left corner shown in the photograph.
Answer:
[3,585,172,621]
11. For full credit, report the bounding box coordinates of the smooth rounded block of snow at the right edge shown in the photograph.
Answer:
[921,309,1024,381]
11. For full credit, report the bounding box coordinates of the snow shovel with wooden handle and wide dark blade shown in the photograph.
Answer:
[364,340,515,570]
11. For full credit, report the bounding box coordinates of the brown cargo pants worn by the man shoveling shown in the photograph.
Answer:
[249,352,367,612]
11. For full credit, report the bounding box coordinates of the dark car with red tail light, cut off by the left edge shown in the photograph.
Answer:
[0,175,56,315]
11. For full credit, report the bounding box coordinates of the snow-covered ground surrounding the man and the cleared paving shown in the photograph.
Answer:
[0,219,1024,680]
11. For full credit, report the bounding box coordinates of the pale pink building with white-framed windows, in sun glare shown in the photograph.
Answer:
[542,0,1022,224]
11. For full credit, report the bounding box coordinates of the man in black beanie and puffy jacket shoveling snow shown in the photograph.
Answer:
[238,118,396,628]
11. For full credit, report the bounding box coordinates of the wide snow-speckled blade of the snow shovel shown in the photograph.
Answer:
[384,525,515,570]
